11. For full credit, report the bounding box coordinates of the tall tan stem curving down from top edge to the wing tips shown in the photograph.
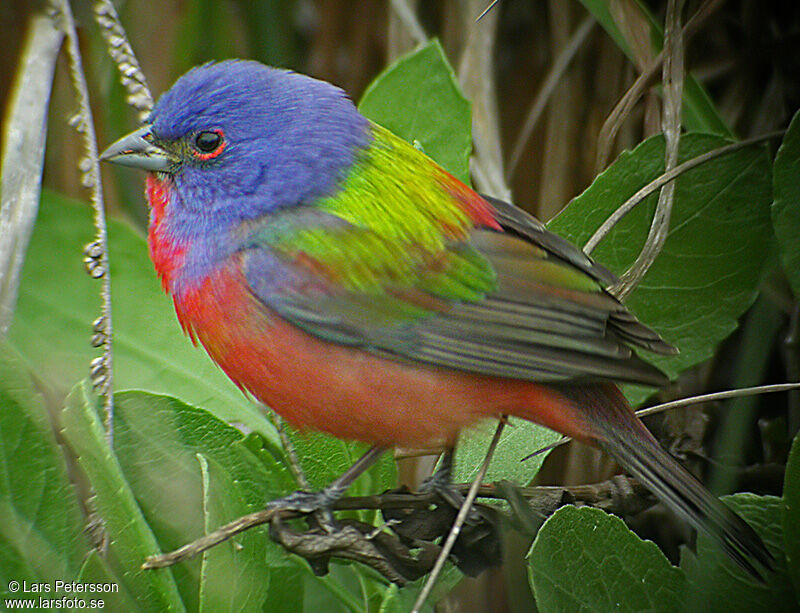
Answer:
[608,0,684,300]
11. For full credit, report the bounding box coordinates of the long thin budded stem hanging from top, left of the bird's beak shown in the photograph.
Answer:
[52,0,114,448]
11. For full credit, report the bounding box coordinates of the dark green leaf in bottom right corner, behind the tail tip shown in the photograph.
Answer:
[681,494,800,613]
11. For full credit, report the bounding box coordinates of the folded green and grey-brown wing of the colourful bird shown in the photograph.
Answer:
[244,194,674,385]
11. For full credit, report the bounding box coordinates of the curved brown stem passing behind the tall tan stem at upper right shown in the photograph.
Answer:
[595,0,725,174]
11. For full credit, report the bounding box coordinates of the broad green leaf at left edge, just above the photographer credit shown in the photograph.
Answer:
[0,342,88,593]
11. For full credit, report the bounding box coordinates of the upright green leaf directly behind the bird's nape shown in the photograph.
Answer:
[358,40,472,184]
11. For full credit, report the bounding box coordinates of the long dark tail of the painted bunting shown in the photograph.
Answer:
[559,384,774,581]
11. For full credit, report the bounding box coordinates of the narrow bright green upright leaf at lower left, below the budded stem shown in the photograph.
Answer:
[62,383,185,613]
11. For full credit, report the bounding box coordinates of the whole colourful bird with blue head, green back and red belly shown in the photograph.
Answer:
[100,60,773,578]
